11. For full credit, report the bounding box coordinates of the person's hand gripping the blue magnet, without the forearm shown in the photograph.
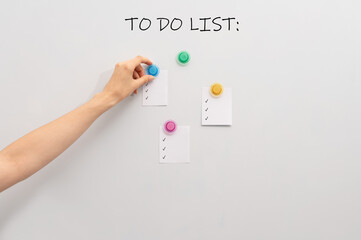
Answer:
[102,56,154,103]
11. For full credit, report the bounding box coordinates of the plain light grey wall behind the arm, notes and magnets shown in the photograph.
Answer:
[0,0,361,240]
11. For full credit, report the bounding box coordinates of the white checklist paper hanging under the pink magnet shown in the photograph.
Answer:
[159,126,190,163]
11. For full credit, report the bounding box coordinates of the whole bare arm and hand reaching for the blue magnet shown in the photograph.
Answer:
[0,56,154,192]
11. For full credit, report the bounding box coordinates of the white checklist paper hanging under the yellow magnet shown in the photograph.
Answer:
[202,87,232,125]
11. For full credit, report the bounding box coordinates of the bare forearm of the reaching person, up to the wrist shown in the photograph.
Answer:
[0,93,116,192]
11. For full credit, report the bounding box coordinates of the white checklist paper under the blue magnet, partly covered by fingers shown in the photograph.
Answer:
[143,70,168,106]
